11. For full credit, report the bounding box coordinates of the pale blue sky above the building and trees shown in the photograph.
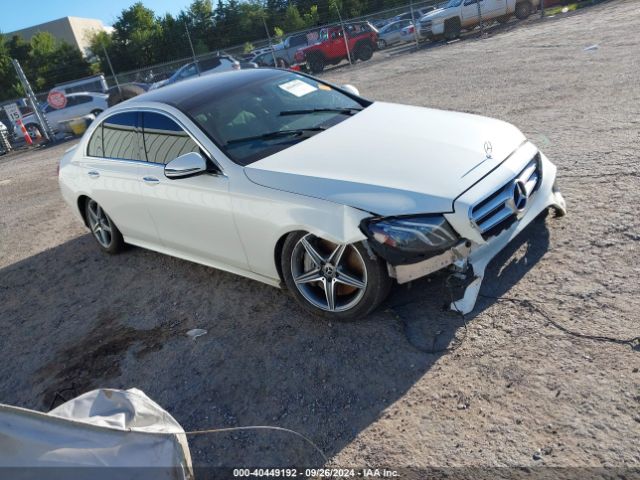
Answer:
[0,0,191,33]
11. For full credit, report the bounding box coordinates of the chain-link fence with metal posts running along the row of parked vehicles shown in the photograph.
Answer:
[0,0,578,151]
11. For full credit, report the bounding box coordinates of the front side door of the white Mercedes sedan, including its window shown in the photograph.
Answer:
[139,111,248,268]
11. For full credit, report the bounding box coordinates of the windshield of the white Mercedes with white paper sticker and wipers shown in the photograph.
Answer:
[186,71,368,165]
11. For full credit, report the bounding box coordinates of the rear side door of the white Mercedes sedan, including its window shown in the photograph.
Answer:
[79,112,159,246]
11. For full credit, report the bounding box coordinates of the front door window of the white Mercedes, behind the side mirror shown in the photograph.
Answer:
[143,112,200,164]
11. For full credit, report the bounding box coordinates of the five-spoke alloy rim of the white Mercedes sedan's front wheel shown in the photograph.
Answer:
[291,234,367,312]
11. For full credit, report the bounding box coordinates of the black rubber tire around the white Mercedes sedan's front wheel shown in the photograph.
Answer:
[281,232,392,321]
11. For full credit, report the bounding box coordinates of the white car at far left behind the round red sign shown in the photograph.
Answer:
[14,92,109,138]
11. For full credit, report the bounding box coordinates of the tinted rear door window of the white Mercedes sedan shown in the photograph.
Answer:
[102,112,142,160]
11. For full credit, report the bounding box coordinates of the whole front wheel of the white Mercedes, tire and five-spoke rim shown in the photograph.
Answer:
[281,232,391,320]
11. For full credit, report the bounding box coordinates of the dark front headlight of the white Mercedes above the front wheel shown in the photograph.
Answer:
[360,215,460,265]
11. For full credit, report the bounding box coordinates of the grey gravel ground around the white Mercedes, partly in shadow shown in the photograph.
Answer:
[0,0,640,468]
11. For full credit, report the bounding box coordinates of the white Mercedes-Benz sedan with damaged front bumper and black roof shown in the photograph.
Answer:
[59,69,565,319]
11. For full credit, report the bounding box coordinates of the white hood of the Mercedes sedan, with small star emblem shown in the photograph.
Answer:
[245,102,525,215]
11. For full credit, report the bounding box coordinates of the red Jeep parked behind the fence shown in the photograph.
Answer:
[295,22,378,73]
